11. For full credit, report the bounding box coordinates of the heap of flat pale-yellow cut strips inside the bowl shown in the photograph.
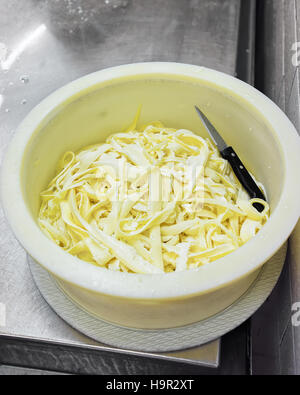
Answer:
[38,116,269,273]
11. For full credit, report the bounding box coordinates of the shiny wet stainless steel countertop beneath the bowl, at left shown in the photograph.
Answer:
[0,0,240,374]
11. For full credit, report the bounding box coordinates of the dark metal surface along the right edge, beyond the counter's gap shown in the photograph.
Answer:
[251,0,300,375]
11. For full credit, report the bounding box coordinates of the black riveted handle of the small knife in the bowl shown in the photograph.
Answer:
[220,147,266,212]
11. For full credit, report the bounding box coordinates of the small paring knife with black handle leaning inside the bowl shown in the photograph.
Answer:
[195,106,266,212]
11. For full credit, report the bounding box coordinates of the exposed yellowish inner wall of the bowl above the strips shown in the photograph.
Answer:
[21,74,285,220]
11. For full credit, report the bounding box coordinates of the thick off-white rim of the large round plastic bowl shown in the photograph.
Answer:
[1,62,300,299]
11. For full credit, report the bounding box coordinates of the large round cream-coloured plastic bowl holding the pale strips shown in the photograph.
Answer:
[2,63,300,328]
